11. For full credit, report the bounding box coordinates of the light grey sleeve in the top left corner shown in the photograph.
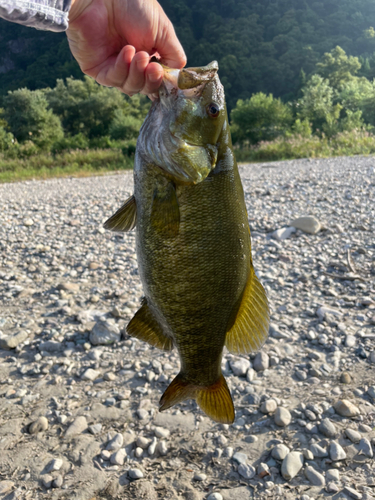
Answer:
[0,0,71,31]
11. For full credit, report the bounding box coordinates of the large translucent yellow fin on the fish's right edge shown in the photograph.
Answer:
[225,266,269,354]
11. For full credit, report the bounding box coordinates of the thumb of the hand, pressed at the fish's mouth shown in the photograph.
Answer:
[155,19,186,69]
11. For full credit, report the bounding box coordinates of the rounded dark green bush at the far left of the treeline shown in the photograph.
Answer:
[4,89,63,150]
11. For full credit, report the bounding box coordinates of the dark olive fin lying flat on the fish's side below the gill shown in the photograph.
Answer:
[151,182,180,238]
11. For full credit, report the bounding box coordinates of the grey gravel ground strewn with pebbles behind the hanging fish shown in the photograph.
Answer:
[0,157,375,500]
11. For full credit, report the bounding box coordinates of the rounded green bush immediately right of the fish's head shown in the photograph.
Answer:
[231,92,293,144]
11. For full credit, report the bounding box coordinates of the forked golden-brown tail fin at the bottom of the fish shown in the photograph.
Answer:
[159,373,234,424]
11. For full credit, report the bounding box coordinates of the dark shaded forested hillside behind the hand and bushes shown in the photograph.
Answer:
[0,0,375,107]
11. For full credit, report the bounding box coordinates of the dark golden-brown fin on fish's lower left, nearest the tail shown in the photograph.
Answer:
[126,302,173,351]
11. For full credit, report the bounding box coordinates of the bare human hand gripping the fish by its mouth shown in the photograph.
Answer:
[66,0,186,95]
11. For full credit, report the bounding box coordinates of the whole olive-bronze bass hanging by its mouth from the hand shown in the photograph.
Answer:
[104,61,269,424]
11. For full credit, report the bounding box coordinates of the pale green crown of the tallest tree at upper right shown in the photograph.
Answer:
[316,46,361,90]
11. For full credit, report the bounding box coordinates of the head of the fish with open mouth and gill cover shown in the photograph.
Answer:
[137,61,227,184]
